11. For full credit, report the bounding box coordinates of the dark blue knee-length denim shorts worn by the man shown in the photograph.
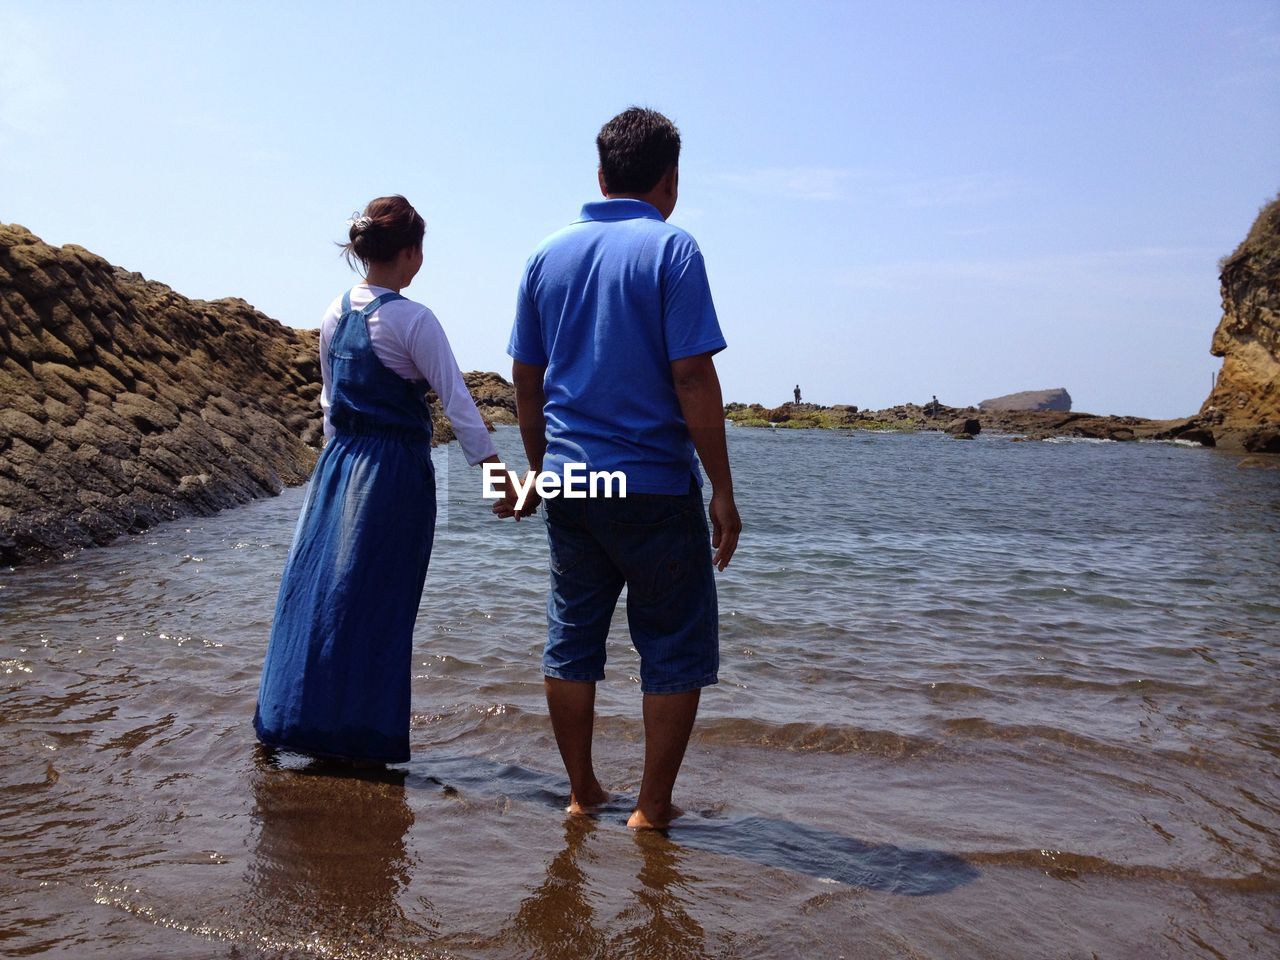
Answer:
[543,484,719,694]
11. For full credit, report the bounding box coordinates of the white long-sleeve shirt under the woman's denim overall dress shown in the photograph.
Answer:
[320,283,498,466]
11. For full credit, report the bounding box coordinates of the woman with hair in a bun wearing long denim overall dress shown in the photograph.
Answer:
[253,196,498,763]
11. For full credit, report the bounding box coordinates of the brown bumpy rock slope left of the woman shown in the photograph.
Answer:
[0,224,321,563]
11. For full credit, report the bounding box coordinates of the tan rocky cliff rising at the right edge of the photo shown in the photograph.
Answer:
[1201,197,1280,453]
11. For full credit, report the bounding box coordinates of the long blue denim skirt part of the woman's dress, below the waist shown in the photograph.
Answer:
[253,434,435,763]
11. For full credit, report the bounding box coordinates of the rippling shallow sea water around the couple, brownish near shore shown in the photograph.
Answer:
[0,429,1280,957]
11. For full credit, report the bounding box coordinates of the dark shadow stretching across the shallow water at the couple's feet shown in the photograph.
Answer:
[404,756,978,896]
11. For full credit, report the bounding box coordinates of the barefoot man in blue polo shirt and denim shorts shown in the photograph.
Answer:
[507,108,742,829]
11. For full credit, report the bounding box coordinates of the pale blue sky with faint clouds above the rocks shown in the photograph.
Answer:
[0,0,1280,417]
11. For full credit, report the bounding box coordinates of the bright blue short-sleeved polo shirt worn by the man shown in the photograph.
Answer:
[507,200,724,494]
